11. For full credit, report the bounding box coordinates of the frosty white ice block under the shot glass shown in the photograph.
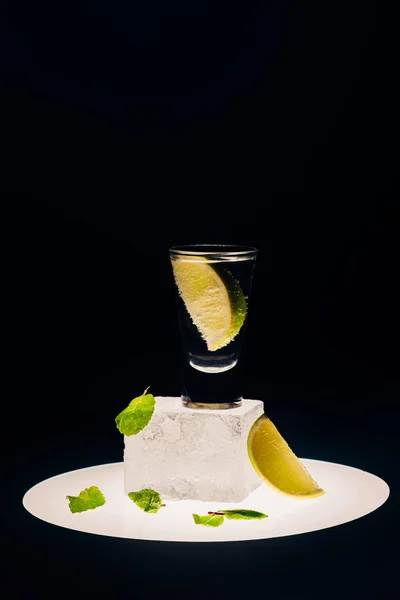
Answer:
[124,396,264,502]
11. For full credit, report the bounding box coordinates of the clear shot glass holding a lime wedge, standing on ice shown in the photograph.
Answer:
[169,244,258,409]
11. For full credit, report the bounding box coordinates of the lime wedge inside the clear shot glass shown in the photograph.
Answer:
[172,257,247,351]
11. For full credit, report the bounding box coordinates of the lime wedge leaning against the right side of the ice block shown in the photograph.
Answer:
[247,415,325,498]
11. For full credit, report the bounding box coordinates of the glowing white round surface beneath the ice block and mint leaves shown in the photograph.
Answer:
[23,459,390,542]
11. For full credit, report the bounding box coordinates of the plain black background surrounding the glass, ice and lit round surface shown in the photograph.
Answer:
[0,0,400,598]
